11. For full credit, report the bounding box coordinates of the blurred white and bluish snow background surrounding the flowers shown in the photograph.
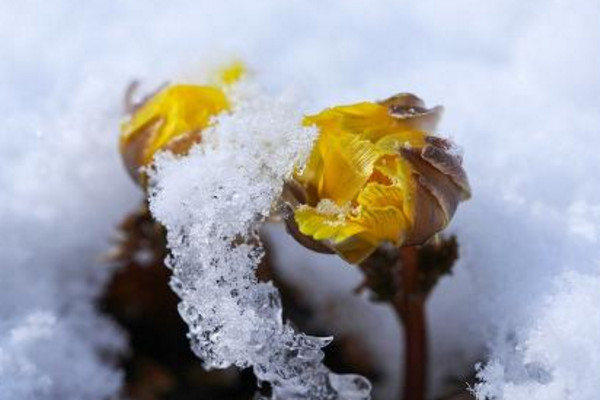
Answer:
[0,0,600,400]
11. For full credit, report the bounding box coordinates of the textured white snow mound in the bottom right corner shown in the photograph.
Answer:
[477,272,600,400]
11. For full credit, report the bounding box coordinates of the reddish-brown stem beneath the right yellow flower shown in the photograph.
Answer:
[394,246,427,400]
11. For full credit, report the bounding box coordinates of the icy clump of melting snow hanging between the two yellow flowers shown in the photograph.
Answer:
[150,83,371,400]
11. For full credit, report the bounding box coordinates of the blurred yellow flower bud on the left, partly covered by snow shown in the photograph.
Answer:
[120,62,245,185]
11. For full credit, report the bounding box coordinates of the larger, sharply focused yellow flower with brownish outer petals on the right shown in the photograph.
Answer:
[288,94,469,263]
